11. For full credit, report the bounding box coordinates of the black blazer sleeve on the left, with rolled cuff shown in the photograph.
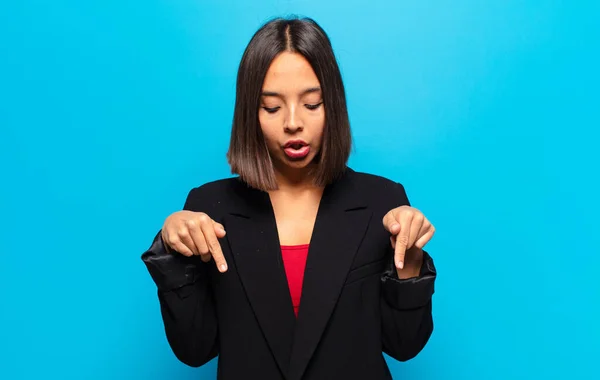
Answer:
[142,189,218,367]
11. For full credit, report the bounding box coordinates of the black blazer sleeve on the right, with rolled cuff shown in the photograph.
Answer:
[380,184,437,361]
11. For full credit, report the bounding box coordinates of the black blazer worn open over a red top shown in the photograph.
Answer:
[142,169,436,380]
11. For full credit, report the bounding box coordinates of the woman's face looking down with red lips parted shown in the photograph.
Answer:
[258,52,325,177]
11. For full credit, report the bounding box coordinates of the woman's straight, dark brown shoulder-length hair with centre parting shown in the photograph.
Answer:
[227,18,352,191]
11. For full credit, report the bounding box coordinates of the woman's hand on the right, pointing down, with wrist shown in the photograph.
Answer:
[383,206,435,278]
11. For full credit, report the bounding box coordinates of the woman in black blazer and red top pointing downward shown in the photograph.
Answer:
[142,19,436,380]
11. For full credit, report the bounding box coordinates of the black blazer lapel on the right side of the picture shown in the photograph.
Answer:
[288,169,372,380]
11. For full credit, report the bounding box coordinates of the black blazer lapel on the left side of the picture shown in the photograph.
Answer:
[224,183,296,377]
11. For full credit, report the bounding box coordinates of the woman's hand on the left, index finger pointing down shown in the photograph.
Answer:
[161,210,227,272]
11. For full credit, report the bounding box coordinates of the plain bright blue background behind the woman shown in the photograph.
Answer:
[0,0,600,379]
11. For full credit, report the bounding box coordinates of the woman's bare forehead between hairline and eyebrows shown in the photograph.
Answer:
[263,52,319,91]
